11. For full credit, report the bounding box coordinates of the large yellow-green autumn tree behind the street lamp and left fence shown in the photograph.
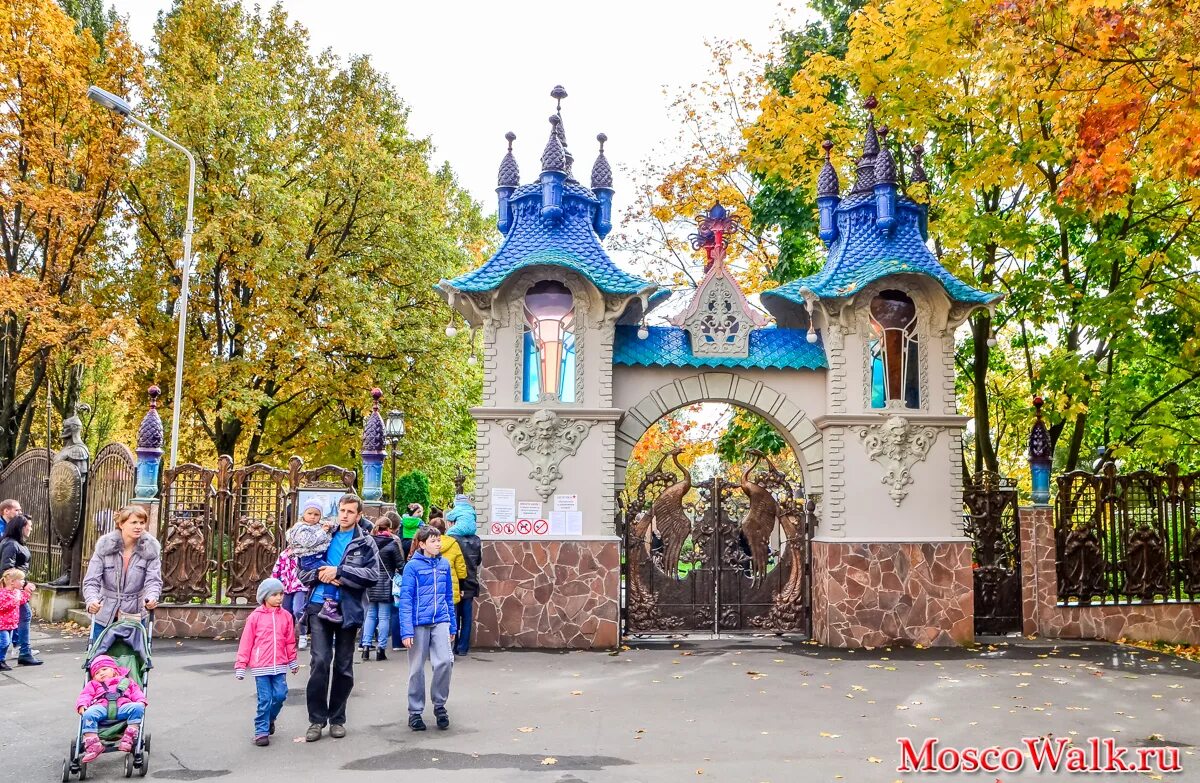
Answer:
[115,0,488,491]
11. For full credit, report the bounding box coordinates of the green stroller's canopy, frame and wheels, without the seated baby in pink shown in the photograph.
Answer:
[62,614,154,782]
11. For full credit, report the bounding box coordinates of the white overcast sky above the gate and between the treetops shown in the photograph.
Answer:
[113,0,794,207]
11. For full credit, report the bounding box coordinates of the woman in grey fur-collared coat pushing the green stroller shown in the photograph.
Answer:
[83,506,162,641]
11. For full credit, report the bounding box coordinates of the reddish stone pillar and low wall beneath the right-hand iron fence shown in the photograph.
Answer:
[1020,506,1200,645]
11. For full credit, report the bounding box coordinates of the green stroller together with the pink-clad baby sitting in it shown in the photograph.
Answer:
[62,618,152,781]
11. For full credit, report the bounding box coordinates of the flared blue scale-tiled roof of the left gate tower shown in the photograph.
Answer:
[444,183,655,294]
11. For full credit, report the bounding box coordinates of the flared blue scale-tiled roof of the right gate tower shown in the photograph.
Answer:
[761,195,1000,305]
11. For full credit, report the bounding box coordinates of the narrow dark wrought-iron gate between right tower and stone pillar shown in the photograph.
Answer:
[962,471,1021,634]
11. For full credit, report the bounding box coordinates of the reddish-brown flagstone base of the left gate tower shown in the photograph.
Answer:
[472,538,620,650]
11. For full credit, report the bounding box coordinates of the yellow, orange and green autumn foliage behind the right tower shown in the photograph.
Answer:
[746,0,1198,470]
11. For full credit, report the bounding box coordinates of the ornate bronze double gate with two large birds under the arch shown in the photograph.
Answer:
[624,449,815,634]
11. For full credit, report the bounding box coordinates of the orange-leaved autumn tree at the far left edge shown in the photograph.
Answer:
[0,0,143,460]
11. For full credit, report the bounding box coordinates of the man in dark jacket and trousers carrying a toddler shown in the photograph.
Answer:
[299,495,379,742]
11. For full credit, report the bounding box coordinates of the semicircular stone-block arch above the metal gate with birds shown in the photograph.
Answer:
[613,372,824,497]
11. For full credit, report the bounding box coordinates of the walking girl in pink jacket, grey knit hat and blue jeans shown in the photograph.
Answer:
[234,578,299,746]
